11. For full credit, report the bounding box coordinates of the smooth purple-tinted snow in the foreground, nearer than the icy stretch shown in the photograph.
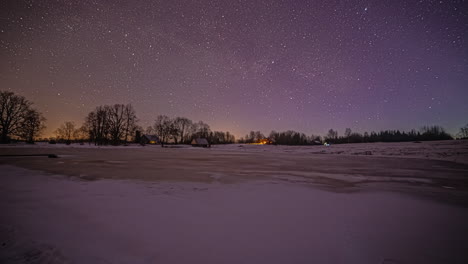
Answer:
[0,165,468,264]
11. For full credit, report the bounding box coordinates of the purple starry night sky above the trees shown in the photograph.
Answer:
[0,0,468,136]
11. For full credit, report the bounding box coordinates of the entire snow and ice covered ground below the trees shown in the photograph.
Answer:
[0,141,468,263]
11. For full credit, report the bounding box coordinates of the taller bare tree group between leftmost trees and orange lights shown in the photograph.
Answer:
[53,109,235,146]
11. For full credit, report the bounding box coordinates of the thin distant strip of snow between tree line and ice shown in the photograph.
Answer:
[0,140,468,164]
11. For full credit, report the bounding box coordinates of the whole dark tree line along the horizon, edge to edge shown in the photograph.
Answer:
[0,91,468,145]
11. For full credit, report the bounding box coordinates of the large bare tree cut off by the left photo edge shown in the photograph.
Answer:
[0,91,31,143]
